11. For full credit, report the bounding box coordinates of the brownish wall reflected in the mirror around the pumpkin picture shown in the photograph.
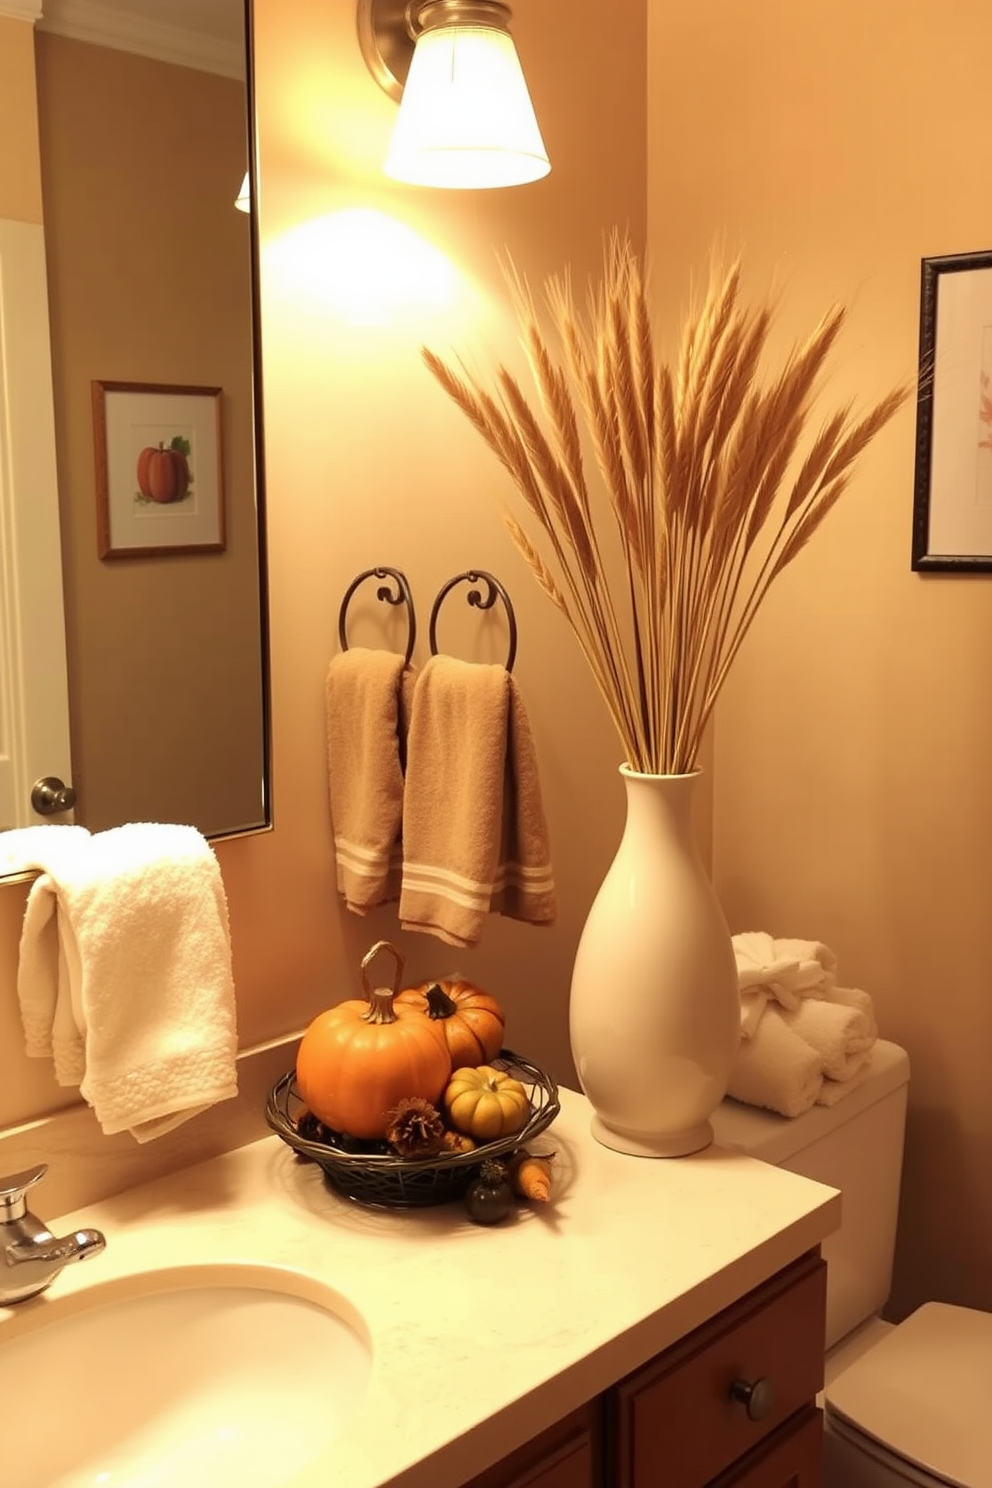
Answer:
[36,33,262,833]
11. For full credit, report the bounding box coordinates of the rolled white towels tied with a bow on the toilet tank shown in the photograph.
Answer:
[729,931,877,1116]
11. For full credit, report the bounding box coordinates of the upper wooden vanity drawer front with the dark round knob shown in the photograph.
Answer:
[613,1253,827,1488]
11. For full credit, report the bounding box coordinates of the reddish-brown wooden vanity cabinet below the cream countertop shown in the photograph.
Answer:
[466,1250,827,1488]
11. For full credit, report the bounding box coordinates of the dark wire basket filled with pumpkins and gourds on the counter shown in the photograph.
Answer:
[266,940,559,1223]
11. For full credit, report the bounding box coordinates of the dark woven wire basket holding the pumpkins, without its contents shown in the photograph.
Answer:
[265,1049,561,1208]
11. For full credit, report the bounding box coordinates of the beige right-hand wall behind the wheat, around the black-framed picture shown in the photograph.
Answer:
[648,0,992,1315]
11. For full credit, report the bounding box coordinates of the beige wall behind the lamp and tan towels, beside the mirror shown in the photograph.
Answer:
[0,0,645,1161]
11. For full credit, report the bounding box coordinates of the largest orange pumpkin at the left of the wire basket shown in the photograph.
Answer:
[296,940,451,1138]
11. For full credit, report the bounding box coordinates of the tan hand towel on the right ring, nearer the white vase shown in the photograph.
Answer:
[400,656,555,946]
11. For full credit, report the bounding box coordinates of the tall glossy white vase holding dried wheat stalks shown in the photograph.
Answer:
[424,237,909,1156]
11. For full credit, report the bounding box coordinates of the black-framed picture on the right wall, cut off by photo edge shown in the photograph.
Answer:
[913,250,992,573]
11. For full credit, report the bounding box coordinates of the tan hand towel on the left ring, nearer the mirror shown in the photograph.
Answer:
[326,647,413,915]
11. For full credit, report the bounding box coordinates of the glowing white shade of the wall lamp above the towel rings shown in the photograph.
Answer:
[384,25,550,189]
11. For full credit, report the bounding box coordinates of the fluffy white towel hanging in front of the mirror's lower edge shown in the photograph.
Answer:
[18,823,238,1141]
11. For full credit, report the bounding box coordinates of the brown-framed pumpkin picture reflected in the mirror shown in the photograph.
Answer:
[92,382,225,558]
